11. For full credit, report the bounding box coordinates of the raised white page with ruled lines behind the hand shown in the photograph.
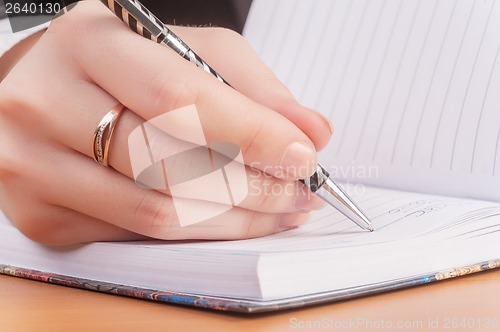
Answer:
[244,0,500,201]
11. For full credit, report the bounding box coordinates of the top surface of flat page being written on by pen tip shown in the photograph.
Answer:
[168,187,500,252]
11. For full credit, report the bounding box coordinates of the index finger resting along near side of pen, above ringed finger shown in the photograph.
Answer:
[58,2,316,179]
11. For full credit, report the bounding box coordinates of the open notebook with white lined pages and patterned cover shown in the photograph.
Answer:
[0,0,500,312]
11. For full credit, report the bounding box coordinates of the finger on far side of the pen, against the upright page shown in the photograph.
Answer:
[171,26,333,150]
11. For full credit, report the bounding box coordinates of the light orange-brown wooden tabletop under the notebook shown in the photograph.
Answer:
[0,271,500,332]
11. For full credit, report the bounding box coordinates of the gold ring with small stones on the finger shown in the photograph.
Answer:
[92,104,125,166]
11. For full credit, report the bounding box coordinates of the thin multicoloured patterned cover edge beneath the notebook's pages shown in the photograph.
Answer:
[0,259,500,313]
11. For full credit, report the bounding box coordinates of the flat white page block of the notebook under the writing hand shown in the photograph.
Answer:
[0,188,500,299]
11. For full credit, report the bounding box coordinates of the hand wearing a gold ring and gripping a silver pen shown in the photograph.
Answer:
[0,1,331,245]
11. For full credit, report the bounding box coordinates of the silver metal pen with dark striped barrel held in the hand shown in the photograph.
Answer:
[101,0,373,231]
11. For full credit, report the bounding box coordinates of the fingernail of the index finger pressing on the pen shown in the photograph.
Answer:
[280,142,316,179]
